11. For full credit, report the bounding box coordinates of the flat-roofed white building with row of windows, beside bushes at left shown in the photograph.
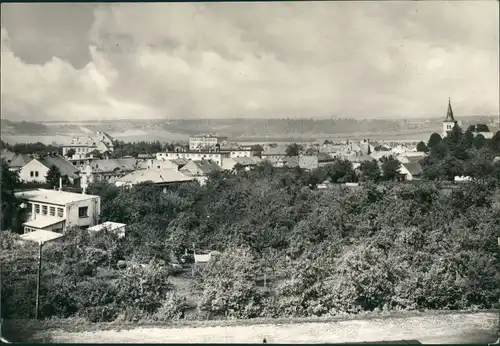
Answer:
[16,189,101,233]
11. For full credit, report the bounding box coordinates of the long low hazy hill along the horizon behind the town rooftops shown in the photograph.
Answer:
[1,115,498,142]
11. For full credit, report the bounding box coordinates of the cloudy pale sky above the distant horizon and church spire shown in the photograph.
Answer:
[1,1,500,121]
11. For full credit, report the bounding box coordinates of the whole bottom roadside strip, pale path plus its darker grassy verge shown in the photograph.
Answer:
[4,311,498,343]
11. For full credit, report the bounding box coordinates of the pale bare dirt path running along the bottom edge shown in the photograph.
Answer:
[38,313,498,344]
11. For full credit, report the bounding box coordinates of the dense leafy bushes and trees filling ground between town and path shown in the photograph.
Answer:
[0,131,500,321]
